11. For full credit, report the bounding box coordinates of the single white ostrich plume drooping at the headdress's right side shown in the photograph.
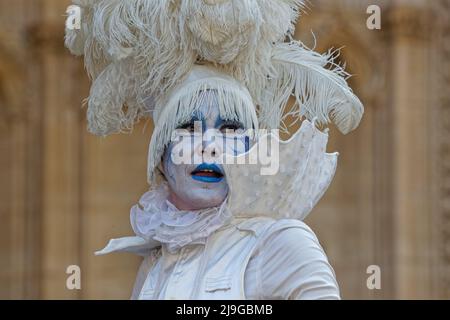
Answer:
[260,41,364,134]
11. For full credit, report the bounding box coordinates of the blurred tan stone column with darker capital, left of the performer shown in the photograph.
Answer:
[30,17,82,299]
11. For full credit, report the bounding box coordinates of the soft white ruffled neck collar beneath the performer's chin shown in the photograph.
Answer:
[131,183,232,252]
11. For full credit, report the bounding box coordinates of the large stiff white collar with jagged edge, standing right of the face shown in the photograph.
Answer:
[224,120,339,220]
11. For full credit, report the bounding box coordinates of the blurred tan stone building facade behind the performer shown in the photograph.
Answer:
[0,0,450,299]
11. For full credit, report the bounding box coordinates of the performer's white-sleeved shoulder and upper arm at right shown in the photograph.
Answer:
[248,219,339,299]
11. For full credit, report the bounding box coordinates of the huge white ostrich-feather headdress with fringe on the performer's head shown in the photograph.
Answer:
[66,0,363,182]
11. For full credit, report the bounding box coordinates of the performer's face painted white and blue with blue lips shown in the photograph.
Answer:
[162,92,249,210]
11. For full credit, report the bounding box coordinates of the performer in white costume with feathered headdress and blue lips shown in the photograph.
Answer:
[66,0,363,299]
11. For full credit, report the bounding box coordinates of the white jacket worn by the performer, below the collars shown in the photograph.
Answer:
[132,218,339,300]
